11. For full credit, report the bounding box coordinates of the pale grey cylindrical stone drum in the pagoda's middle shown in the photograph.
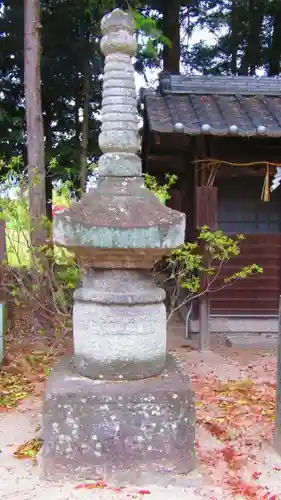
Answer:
[73,271,166,380]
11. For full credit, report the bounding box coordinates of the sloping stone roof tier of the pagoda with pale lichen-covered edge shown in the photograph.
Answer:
[54,177,185,249]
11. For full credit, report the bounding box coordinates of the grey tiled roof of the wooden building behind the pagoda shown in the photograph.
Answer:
[144,74,281,137]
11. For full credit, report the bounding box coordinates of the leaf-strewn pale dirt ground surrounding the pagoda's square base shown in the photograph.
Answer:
[0,322,281,500]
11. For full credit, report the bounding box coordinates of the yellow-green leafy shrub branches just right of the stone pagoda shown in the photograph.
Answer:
[145,174,263,314]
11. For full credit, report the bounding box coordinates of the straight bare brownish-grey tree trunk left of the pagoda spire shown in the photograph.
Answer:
[24,0,46,249]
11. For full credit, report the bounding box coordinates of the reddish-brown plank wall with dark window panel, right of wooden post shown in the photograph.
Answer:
[210,177,281,315]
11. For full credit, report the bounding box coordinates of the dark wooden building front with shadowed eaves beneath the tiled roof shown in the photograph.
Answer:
[143,129,281,315]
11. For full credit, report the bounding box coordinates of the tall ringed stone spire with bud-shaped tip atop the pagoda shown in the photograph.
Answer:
[99,9,141,177]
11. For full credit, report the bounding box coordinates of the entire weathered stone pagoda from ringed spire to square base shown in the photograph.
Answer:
[41,9,195,484]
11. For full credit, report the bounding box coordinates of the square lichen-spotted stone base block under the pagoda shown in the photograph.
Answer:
[42,357,195,485]
